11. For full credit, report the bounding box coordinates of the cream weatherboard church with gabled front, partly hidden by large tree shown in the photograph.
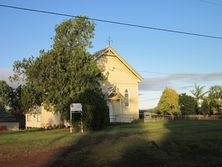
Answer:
[26,46,143,127]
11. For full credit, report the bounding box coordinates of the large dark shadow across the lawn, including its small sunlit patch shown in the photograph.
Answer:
[48,121,222,167]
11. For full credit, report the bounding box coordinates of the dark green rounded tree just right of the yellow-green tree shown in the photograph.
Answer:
[179,93,196,115]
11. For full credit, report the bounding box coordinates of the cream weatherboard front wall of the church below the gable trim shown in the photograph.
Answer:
[97,47,139,122]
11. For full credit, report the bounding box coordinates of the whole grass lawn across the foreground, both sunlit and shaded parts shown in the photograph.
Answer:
[0,121,222,167]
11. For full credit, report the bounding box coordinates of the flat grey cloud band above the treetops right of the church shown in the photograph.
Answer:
[139,72,222,91]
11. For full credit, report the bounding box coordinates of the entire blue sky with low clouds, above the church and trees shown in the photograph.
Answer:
[0,0,222,109]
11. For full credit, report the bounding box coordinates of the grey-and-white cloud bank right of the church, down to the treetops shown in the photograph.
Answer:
[139,72,222,109]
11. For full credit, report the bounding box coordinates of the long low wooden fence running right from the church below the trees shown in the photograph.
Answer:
[144,112,222,122]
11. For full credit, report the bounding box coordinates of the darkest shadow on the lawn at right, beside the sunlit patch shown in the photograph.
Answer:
[115,120,222,167]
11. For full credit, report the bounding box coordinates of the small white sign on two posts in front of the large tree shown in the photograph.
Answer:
[70,103,83,133]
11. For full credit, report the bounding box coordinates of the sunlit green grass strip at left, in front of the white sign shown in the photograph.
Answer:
[0,129,81,154]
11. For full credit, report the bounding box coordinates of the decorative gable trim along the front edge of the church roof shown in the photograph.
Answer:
[93,46,143,82]
